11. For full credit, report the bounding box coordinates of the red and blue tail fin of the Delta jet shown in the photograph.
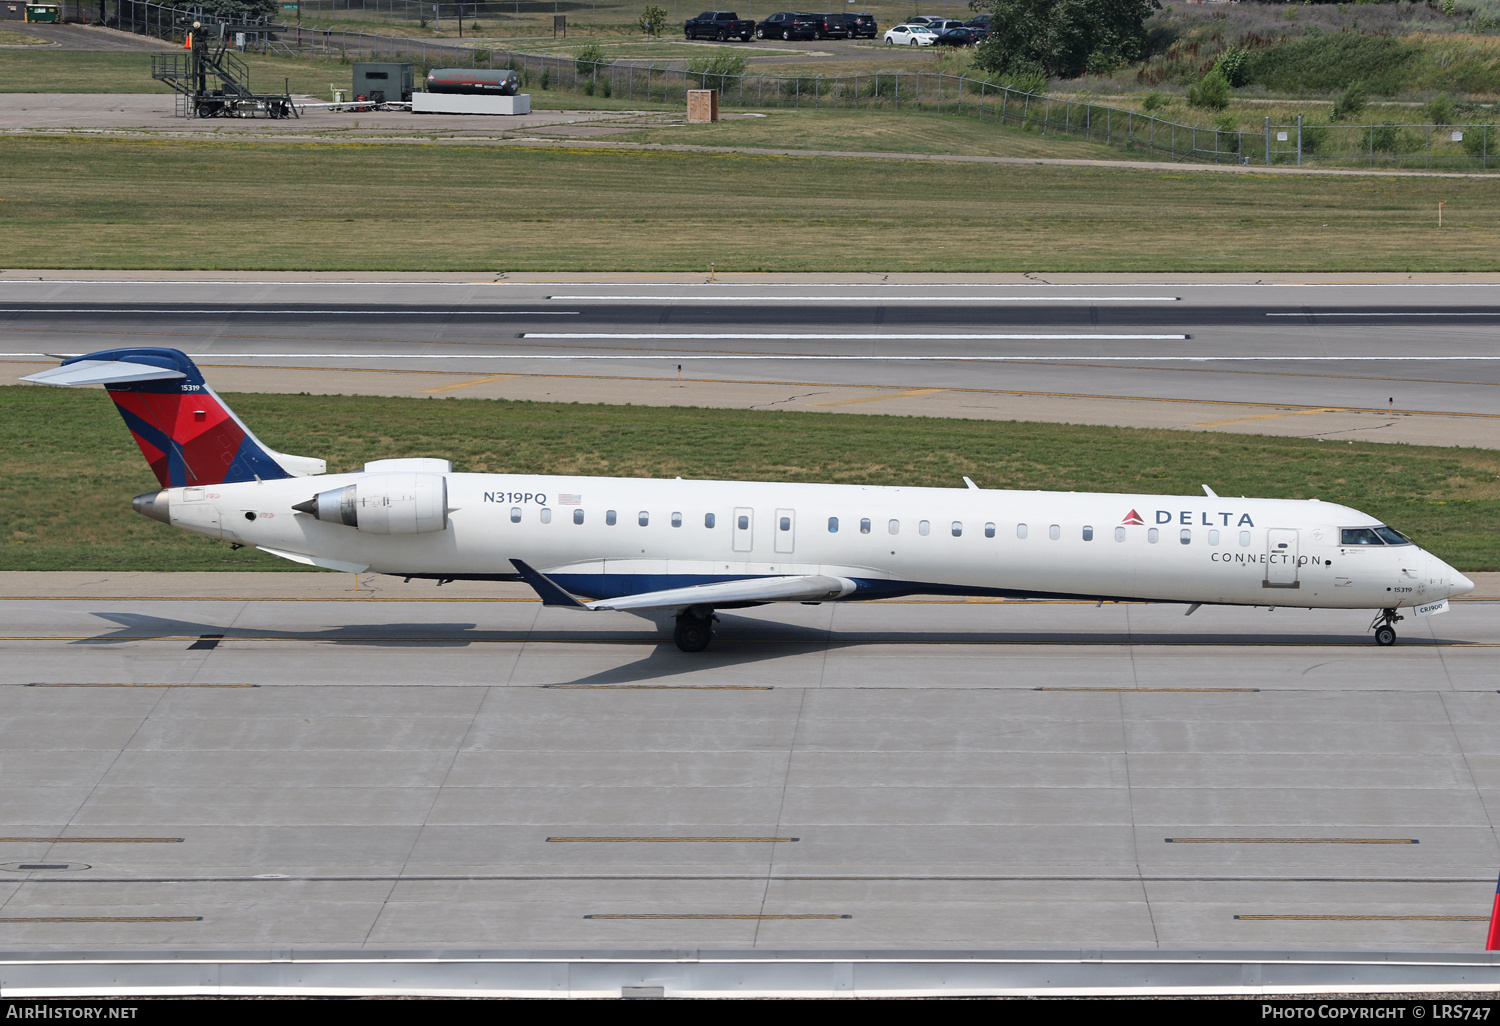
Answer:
[23,348,327,488]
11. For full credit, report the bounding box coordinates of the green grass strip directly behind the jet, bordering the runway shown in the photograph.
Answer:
[0,386,1500,570]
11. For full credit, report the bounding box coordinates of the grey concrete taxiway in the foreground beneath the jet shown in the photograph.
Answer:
[0,575,1500,950]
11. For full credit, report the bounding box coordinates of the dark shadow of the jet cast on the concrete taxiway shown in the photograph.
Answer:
[72,612,1464,686]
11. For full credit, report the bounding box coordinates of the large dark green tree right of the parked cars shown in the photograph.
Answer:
[969,0,1161,78]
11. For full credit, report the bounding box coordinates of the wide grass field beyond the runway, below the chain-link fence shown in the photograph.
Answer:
[0,138,1500,273]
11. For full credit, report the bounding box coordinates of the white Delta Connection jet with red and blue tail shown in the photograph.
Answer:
[26,348,1473,653]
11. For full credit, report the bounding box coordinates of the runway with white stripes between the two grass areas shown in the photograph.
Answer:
[0,273,1500,447]
